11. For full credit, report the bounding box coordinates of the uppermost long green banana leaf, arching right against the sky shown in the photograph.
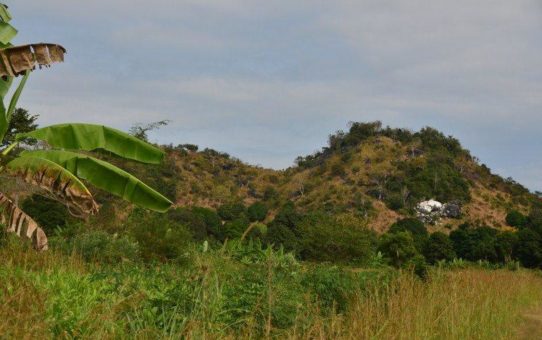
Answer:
[17,123,164,164]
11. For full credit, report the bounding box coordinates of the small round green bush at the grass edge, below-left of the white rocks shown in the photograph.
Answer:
[378,231,418,268]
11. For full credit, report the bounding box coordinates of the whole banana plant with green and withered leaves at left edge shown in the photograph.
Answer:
[0,4,172,250]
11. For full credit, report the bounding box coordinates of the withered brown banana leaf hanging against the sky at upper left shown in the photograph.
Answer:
[0,43,66,77]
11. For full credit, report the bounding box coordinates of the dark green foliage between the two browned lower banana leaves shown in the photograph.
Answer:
[21,195,68,233]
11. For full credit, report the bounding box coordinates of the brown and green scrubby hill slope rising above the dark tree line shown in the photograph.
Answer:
[117,122,541,232]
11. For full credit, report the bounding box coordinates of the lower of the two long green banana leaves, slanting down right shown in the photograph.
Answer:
[21,150,172,212]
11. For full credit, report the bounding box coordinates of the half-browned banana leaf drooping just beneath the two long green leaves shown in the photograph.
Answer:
[7,157,98,214]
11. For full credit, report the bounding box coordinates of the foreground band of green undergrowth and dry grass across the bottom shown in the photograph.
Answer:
[0,238,542,339]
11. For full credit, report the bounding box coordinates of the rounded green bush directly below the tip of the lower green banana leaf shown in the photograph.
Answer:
[128,209,192,261]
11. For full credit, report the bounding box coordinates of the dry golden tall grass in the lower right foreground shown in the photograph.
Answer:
[296,269,542,339]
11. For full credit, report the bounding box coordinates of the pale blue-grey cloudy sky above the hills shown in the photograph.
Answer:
[4,0,542,190]
